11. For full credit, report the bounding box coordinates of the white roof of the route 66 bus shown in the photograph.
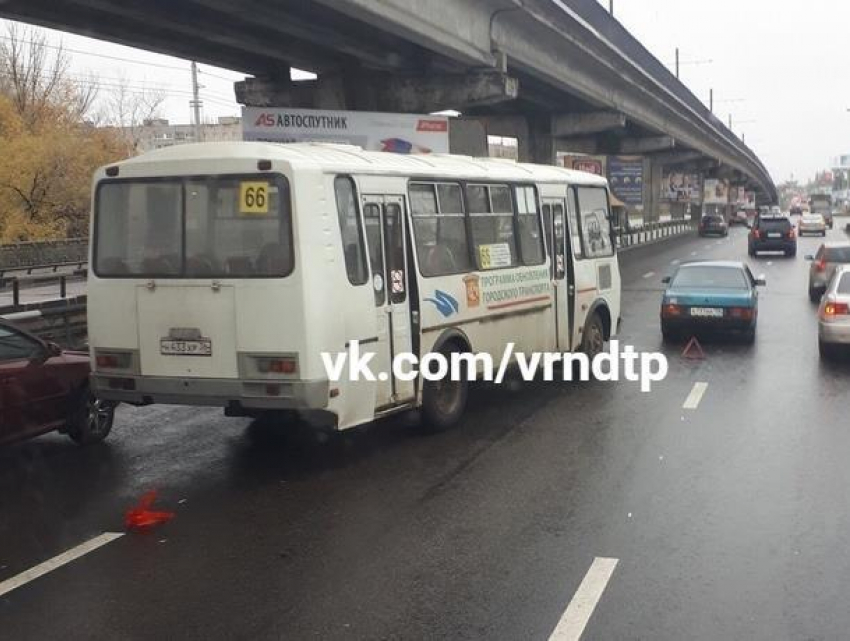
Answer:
[104,142,606,185]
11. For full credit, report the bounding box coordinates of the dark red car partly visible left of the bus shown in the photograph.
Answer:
[0,321,115,445]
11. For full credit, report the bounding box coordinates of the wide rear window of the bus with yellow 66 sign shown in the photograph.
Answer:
[94,175,294,278]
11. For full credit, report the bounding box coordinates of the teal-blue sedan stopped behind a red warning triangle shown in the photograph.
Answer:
[661,261,766,342]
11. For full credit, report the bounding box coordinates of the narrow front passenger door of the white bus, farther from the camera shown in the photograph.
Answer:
[543,198,575,350]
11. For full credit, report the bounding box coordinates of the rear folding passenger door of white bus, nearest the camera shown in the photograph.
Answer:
[363,196,415,410]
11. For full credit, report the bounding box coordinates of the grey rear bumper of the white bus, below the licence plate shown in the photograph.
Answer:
[91,374,330,410]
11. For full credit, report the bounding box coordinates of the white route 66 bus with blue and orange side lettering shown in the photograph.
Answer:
[88,142,620,430]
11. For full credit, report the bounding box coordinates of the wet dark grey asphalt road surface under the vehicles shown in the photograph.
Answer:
[0,225,850,639]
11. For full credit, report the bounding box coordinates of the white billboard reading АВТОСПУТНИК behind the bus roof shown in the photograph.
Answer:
[242,107,449,154]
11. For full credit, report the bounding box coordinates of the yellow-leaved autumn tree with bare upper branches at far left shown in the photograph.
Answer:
[0,26,130,243]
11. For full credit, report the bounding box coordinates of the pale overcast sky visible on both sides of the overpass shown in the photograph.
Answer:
[0,0,850,181]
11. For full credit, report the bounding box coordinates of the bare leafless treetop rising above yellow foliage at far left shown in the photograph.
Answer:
[0,23,97,125]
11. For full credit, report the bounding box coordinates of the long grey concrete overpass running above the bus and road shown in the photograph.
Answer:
[0,0,776,210]
